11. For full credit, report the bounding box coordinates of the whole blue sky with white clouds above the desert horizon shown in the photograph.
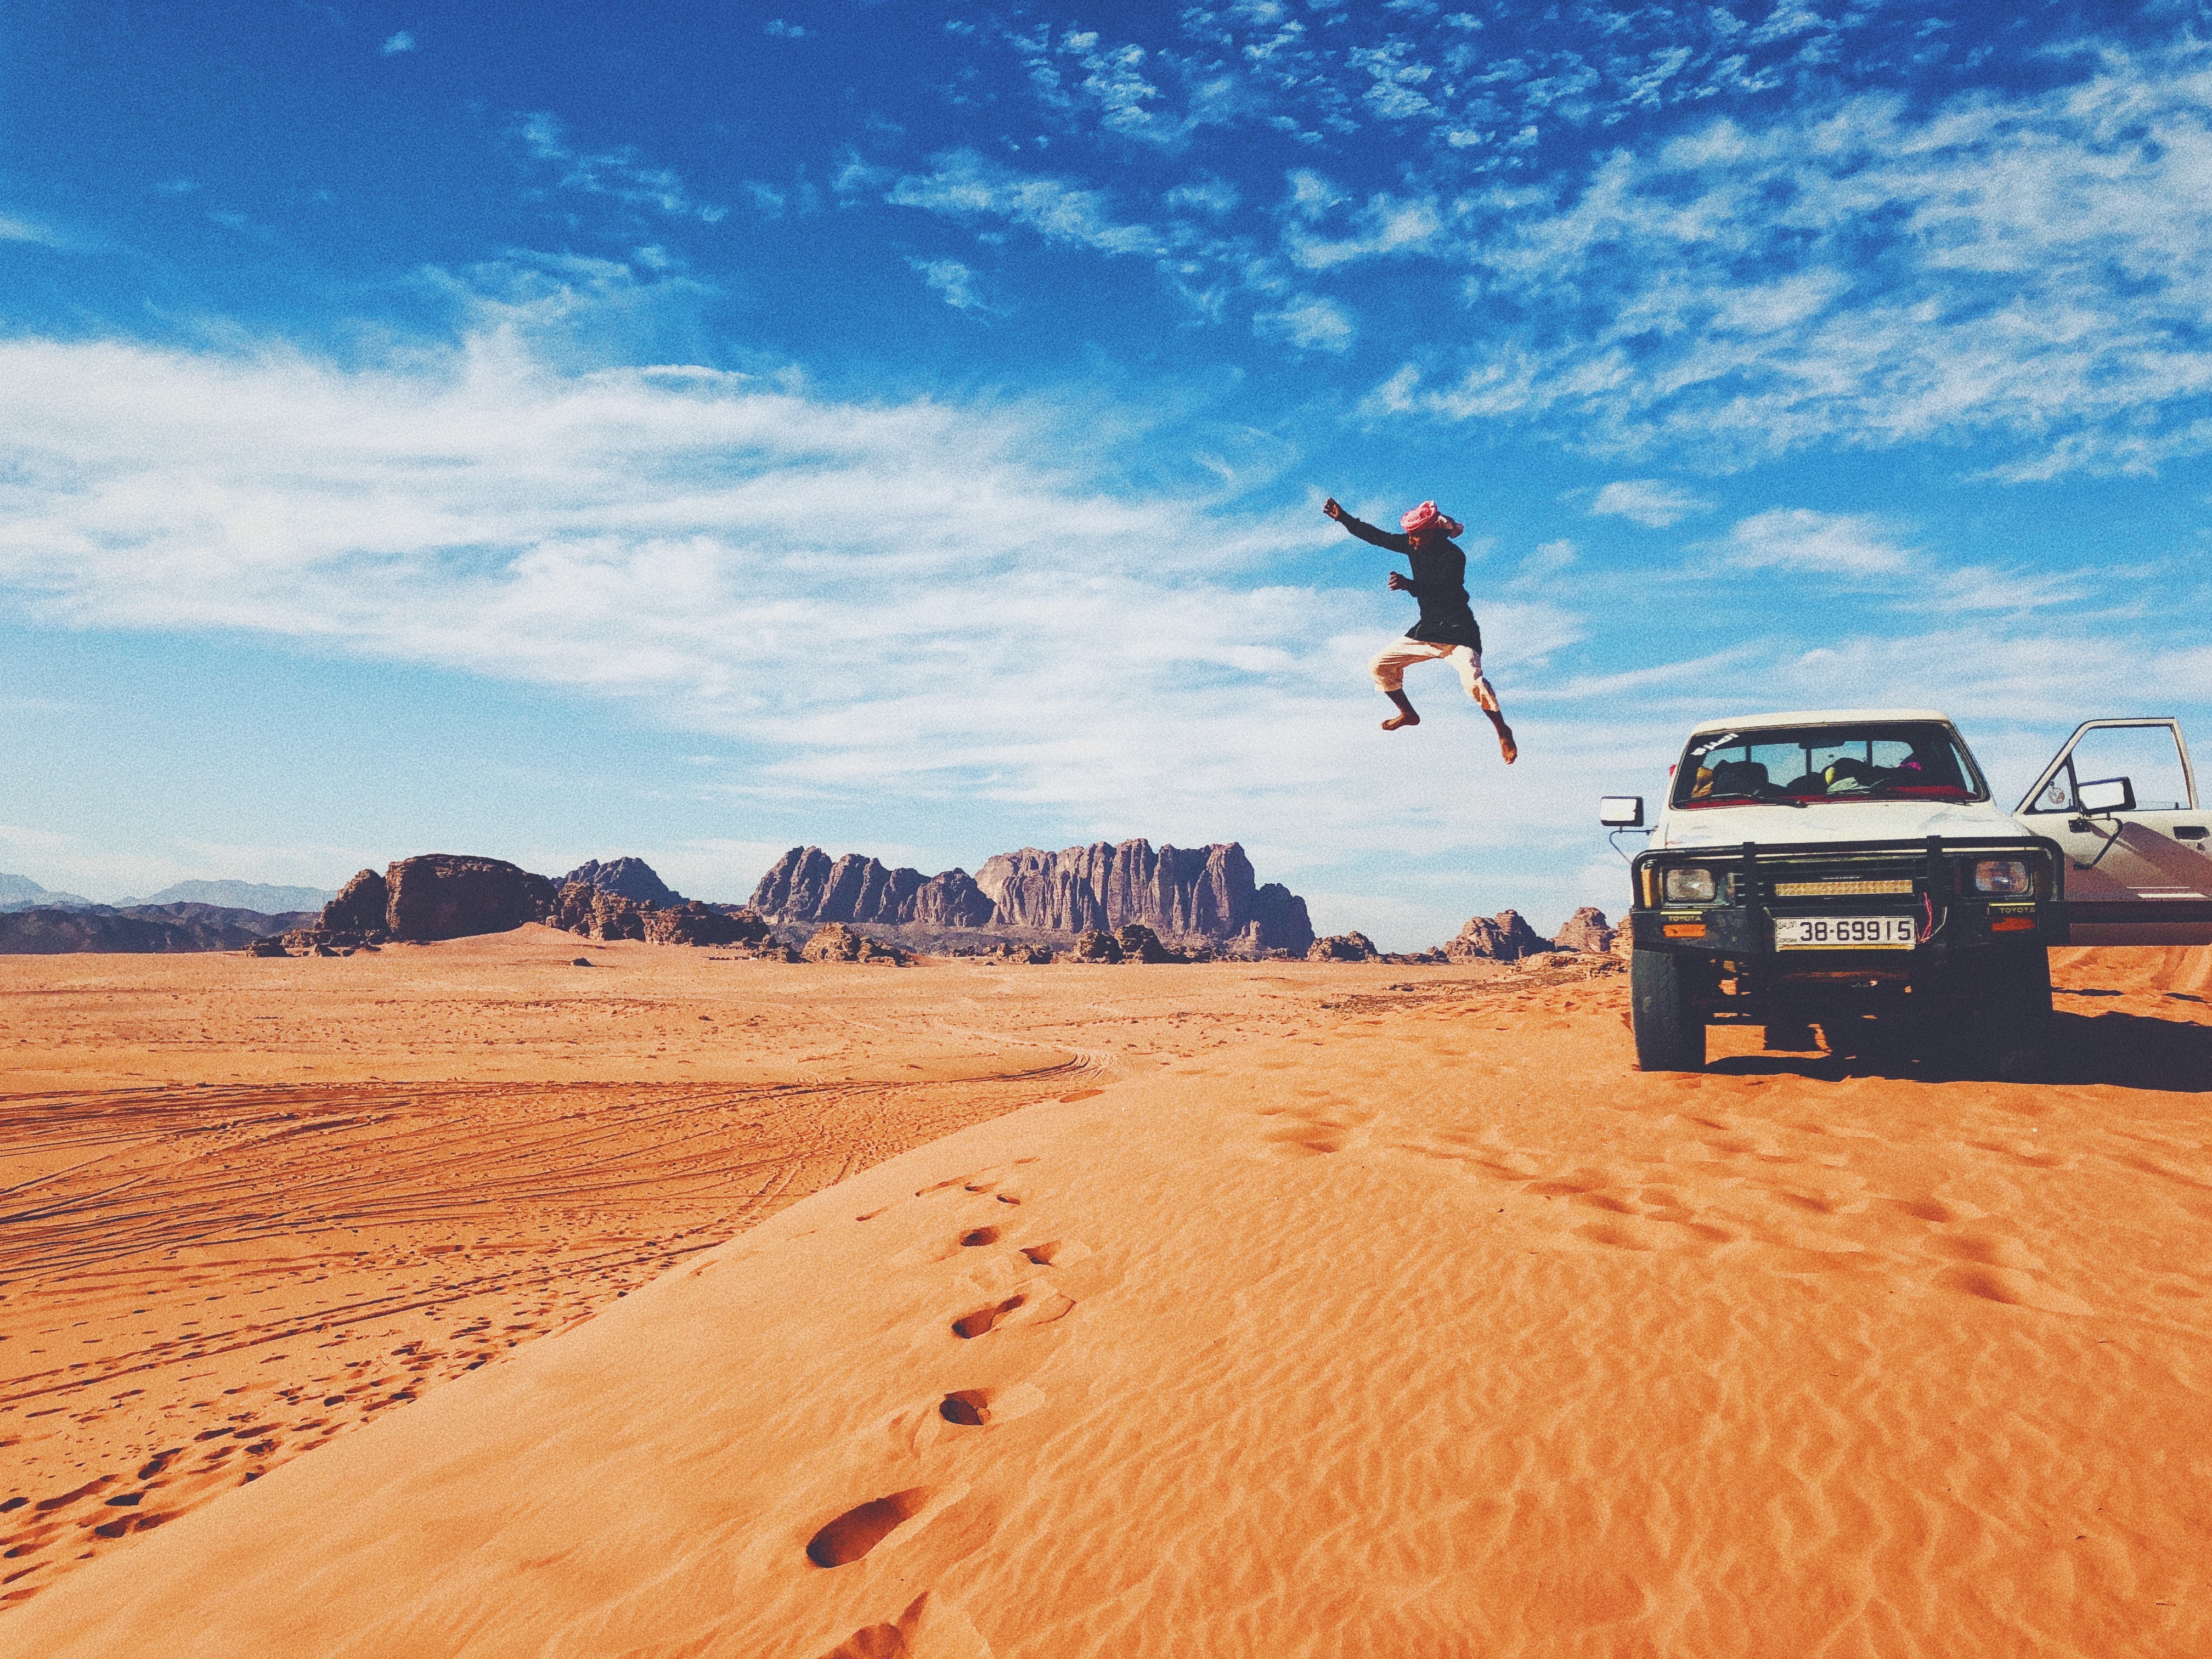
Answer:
[0,0,2212,947]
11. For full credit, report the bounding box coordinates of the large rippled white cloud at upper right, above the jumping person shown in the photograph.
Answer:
[1372,37,2212,478]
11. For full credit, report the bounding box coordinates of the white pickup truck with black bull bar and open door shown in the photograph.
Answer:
[1599,708,2212,1070]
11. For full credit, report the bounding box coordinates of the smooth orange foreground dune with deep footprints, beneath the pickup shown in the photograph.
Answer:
[0,951,2212,1659]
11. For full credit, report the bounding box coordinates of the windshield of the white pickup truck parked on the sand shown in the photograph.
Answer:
[1672,721,1989,808]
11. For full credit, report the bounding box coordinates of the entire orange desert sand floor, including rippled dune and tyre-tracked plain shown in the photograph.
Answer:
[0,929,2212,1659]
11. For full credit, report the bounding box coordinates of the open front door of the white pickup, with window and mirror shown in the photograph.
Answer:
[2013,719,2212,945]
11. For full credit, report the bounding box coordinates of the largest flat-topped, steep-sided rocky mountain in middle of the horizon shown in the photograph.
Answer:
[752,840,1314,956]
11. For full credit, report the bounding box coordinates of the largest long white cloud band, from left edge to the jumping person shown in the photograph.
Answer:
[0,327,1579,876]
